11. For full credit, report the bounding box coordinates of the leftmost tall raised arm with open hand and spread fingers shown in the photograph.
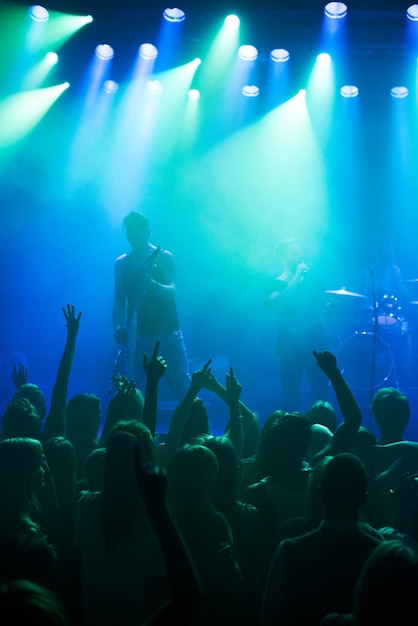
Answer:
[42,304,82,440]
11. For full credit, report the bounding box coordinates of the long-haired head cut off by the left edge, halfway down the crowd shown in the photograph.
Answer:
[0,437,45,528]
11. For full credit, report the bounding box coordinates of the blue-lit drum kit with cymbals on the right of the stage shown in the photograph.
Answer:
[325,279,418,390]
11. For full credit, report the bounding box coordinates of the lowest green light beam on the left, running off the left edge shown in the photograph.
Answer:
[0,83,70,148]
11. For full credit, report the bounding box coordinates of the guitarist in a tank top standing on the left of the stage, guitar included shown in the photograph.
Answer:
[113,211,190,400]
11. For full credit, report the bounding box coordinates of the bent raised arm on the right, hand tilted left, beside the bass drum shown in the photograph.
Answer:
[313,350,362,454]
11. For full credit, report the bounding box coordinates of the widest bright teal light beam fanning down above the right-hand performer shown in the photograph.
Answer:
[196,94,328,273]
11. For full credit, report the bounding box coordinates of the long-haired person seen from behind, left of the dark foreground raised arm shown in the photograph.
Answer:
[74,421,169,626]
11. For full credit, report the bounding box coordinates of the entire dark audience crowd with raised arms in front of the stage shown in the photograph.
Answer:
[0,305,418,626]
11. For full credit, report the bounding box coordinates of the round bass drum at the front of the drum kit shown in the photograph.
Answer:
[337,332,393,390]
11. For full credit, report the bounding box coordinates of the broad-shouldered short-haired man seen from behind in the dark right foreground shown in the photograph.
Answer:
[261,453,380,626]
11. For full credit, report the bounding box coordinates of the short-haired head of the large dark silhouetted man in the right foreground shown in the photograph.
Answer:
[319,452,368,521]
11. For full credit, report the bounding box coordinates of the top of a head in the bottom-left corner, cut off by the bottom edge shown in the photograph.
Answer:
[0,580,70,626]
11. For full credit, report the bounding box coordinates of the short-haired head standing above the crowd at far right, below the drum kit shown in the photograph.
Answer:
[371,387,411,443]
